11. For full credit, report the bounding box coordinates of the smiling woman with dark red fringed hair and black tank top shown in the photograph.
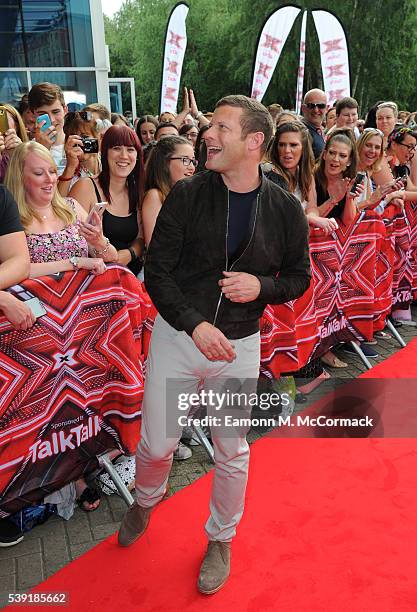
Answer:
[69,125,144,274]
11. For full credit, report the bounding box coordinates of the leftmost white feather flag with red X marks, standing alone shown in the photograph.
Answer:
[160,3,189,113]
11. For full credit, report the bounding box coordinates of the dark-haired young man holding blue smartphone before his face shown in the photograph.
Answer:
[28,83,68,175]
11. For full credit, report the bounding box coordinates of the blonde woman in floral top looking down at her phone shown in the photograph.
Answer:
[5,141,117,278]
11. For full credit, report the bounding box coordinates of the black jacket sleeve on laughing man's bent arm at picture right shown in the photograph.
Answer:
[258,194,311,304]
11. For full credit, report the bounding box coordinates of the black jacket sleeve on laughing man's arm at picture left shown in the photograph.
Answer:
[145,181,206,335]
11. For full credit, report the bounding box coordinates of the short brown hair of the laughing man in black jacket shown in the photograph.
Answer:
[215,95,274,153]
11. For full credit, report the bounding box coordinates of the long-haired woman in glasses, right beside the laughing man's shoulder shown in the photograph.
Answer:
[142,136,197,245]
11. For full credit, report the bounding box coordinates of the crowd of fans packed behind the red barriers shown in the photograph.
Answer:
[0,83,417,544]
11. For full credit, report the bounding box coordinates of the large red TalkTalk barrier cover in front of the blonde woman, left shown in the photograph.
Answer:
[0,265,151,517]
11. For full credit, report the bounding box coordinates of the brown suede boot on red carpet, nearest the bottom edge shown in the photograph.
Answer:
[197,541,231,595]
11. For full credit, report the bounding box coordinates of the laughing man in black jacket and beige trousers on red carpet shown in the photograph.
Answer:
[119,96,310,594]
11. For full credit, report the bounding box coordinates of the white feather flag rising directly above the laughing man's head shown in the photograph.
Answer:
[251,6,300,102]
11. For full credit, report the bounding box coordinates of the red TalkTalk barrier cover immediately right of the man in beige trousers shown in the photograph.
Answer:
[261,213,384,378]
